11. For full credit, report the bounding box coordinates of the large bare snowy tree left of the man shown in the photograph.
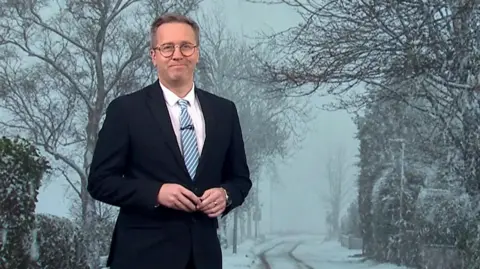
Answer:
[0,0,201,268]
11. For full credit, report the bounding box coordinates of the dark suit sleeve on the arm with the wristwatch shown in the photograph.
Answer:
[221,103,252,216]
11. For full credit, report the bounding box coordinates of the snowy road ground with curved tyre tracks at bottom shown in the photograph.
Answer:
[224,232,408,269]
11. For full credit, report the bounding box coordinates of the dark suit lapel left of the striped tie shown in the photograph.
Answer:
[147,80,190,177]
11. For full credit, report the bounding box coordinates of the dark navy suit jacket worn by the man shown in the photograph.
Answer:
[88,80,252,269]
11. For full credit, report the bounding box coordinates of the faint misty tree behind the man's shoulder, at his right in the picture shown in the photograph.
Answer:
[196,7,308,251]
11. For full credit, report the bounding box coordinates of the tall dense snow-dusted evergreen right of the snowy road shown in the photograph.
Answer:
[356,83,439,265]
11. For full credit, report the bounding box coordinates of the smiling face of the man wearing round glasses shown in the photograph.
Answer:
[150,22,199,85]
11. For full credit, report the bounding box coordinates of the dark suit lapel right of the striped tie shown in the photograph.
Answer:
[195,88,217,180]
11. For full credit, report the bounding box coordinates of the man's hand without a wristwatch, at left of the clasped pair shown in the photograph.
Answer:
[157,183,201,212]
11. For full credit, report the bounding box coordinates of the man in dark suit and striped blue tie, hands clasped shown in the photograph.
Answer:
[88,14,252,269]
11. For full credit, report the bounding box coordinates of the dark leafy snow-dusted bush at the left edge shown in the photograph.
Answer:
[0,137,49,269]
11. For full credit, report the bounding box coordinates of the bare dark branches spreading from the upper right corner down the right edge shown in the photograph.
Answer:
[248,0,480,197]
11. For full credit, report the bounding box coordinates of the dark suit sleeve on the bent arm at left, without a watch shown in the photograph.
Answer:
[87,98,162,208]
